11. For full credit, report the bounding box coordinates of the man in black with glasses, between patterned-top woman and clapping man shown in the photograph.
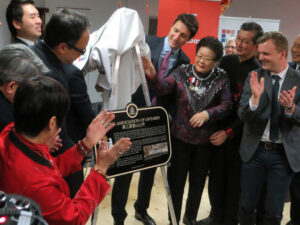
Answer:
[199,22,263,225]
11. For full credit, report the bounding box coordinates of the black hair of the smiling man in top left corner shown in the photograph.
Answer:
[6,0,35,37]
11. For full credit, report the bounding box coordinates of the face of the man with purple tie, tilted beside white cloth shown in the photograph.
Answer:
[168,20,191,50]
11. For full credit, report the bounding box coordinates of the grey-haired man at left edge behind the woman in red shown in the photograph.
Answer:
[0,44,47,132]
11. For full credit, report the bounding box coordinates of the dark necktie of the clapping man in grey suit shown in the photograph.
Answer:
[269,75,280,142]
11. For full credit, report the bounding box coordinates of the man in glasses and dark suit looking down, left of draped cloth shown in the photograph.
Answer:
[32,9,95,197]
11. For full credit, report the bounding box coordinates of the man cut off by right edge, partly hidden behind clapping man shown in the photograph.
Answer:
[287,34,300,225]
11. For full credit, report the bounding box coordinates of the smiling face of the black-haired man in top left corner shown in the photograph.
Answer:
[13,4,42,42]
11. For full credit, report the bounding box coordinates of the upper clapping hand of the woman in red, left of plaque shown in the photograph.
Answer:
[82,110,115,149]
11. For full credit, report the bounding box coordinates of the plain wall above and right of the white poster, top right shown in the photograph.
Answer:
[224,0,300,60]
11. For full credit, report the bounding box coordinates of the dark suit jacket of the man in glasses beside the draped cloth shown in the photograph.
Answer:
[32,41,95,153]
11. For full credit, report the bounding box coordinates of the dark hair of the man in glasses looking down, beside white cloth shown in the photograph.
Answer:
[44,9,89,49]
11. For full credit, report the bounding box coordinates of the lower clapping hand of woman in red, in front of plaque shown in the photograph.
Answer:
[94,138,132,174]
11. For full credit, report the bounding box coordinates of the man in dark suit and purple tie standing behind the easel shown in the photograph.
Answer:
[112,14,198,225]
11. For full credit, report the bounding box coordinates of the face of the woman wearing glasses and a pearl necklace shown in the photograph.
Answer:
[194,47,216,73]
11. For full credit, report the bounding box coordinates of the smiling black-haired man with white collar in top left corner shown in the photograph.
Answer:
[6,0,42,45]
